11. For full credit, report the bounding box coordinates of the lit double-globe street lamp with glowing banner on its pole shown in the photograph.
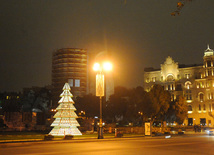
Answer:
[93,62,112,139]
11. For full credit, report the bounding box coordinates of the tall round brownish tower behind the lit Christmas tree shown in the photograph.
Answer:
[52,48,87,106]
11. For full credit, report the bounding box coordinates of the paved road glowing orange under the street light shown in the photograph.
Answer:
[0,136,214,155]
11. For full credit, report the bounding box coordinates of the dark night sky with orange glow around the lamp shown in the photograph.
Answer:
[0,0,214,92]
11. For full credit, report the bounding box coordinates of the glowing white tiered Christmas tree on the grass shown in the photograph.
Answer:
[49,83,82,136]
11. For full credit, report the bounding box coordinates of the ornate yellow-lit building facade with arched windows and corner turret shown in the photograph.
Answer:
[144,46,214,126]
